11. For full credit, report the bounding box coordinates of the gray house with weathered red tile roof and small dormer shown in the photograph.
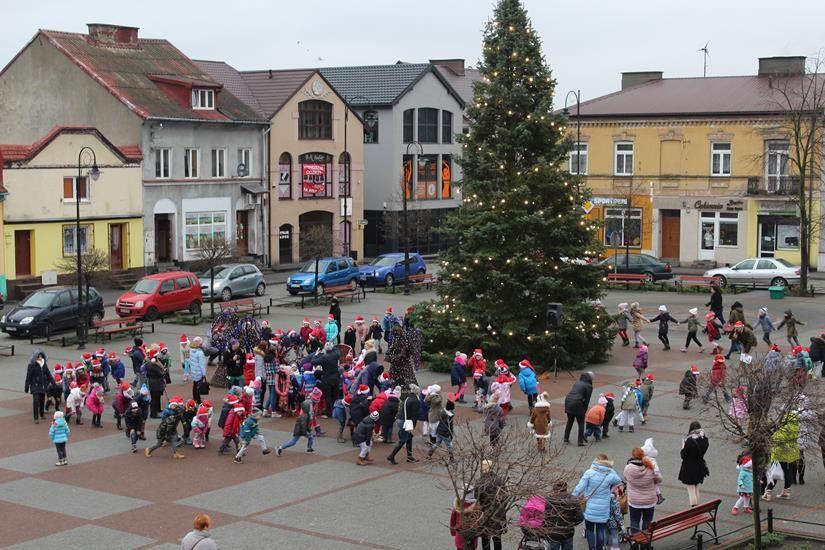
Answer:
[0,24,269,266]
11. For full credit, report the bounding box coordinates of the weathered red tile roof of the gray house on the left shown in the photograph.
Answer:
[35,30,264,122]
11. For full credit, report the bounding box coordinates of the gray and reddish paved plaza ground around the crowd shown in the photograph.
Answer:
[0,291,825,550]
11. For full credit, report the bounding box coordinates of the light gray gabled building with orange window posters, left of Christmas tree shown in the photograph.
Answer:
[321,62,465,256]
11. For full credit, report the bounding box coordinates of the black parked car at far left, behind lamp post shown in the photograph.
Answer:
[0,286,104,336]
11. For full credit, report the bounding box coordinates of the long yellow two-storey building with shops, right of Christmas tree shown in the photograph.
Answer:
[569,57,820,267]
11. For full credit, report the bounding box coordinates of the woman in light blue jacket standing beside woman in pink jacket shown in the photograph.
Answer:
[570,453,622,550]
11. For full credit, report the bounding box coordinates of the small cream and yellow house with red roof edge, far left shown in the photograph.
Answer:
[0,127,143,296]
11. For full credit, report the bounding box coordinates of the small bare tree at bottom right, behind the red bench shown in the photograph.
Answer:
[699,351,825,550]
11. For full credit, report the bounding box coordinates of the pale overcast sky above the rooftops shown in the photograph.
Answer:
[0,0,825,105]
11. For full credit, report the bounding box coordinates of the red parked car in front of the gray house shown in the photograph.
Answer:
[115,271,203,321]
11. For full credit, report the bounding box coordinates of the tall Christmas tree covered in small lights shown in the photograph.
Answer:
[417,0,612,374]
